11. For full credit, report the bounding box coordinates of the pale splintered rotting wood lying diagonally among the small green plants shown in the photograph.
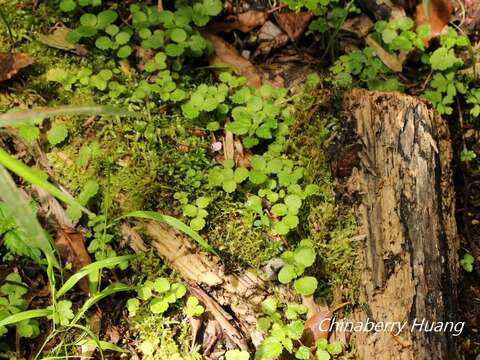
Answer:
[122,222,269,349]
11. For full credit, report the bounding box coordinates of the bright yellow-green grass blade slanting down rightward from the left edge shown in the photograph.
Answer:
[0,148,94,215]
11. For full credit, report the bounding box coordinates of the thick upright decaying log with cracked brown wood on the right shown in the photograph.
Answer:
[344,90,459,360]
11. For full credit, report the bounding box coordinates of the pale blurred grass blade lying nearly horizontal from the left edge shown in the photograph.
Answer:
[0,105,141,127]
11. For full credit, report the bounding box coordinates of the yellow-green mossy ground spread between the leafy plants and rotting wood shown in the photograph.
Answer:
[0,1,358,359]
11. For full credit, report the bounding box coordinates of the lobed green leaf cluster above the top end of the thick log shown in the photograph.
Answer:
[330,17,480,116]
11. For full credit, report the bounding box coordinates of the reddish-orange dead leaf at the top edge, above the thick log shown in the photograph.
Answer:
[415,0,453,43]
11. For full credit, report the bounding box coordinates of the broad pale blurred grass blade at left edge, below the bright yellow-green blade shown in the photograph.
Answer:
[0,165,60,268]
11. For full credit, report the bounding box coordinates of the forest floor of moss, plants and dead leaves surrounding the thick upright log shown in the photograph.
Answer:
[0,0,480,360]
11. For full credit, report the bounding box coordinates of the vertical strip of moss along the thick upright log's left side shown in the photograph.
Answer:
[291,91,359,302]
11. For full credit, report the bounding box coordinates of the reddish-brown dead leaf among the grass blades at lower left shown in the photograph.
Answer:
[55,229,92,295]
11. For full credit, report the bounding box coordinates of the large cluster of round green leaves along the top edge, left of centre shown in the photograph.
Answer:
[60,0,223,60]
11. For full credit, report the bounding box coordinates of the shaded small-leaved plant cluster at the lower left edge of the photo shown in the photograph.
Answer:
[0,272,40,338]
